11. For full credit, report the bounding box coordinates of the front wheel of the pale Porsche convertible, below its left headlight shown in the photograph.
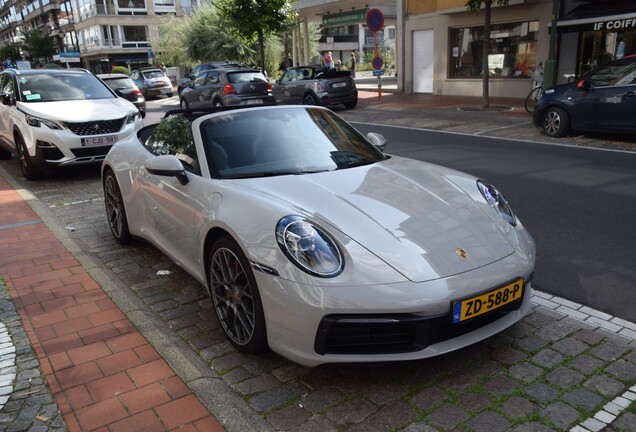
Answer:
[209,236,268,354]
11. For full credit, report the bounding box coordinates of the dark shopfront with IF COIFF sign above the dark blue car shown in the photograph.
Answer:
[557,0,636,82]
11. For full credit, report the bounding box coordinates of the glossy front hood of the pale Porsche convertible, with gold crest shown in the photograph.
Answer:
[243,158,514,282]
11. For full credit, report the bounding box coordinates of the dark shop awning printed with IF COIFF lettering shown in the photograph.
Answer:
[557,0,636,33]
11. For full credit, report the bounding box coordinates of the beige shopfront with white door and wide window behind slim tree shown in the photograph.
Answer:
[403,0,552,98]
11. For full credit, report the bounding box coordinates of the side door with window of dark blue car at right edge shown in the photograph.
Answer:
[572,62,636,130]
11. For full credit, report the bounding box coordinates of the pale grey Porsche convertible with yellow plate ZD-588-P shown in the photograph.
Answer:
[102,106,535,366]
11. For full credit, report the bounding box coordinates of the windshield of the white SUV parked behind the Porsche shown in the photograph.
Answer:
[18,71,116,102]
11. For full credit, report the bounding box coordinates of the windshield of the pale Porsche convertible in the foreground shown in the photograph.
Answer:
[200,107,384,178]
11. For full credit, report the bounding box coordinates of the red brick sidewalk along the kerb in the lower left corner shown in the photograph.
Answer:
[0,176,223,432]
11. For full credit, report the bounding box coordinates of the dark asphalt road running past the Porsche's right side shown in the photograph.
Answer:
[356,124,636,322]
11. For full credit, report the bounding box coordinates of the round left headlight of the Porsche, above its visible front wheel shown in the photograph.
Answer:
[276,216,344,277]
